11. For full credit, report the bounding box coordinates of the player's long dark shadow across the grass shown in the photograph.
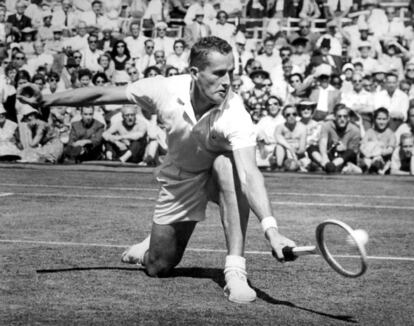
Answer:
[36,266,358,324]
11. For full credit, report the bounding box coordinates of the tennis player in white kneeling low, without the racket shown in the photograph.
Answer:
[19,37,295,303]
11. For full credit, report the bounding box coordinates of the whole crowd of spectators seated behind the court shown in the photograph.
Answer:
[0,0,414,175]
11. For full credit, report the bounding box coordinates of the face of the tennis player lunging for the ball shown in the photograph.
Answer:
[194,51,234,105]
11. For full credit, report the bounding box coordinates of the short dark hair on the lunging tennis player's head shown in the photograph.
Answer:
[189,36,232,70]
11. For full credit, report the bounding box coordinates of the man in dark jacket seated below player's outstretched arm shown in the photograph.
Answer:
[63,107,105,163]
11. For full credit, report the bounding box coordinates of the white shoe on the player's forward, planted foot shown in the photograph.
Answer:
[224,268,256,303]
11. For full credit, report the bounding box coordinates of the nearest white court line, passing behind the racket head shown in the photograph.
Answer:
[0,239,414,262]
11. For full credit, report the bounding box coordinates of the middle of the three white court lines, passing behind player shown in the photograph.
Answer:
[7,192,414,211]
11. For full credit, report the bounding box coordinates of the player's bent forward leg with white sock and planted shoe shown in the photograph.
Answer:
[209,154,256,303]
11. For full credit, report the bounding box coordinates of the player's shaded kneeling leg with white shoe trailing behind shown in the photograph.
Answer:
[122,221,197,276]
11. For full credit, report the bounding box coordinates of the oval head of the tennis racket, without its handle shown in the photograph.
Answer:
[316,220,368,278]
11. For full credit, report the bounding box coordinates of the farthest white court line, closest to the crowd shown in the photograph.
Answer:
[0,183,414,200]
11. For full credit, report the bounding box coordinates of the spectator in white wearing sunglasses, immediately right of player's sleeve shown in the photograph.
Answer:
[256,95,285,167]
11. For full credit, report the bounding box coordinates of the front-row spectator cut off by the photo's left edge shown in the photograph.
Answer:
[0,103,21,161]
